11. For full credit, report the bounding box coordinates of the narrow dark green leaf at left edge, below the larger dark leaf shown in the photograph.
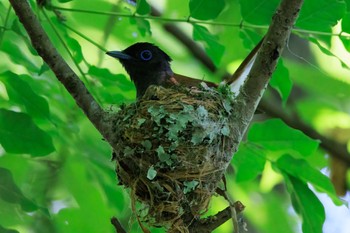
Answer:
[0,167,38,212]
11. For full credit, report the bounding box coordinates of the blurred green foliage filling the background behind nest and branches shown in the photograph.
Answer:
[0,0,350,233]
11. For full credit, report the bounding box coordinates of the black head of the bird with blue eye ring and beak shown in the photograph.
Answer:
[107,42,173,98]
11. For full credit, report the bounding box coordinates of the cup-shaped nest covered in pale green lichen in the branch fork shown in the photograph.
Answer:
[113,86,237,232]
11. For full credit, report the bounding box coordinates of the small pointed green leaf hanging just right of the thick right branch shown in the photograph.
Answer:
[270,59,293,103]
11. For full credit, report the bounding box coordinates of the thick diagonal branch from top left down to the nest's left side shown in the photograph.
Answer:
[10,0,110,144]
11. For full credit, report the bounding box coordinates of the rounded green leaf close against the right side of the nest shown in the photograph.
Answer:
[232,143,266,182]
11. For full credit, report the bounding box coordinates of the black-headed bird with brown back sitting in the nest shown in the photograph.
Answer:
[106,40,262,99]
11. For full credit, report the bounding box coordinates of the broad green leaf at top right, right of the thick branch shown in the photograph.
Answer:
[296,0,346,32]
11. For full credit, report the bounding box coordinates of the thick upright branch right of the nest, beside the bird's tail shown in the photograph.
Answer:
[237,0,303,127]
